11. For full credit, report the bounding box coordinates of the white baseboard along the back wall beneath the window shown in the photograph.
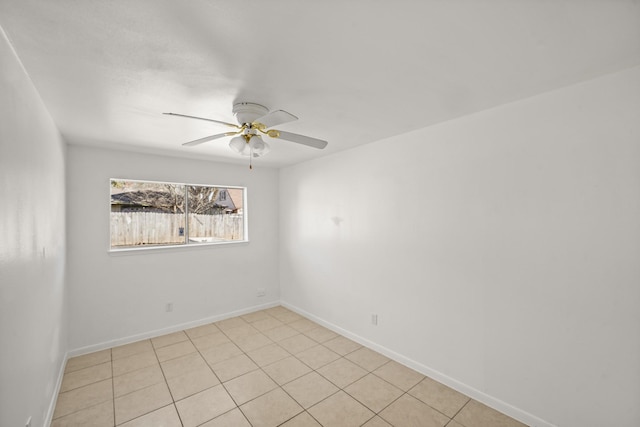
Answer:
[68,301,280,357]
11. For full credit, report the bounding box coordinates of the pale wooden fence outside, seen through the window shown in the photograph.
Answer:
[111,212,244,247]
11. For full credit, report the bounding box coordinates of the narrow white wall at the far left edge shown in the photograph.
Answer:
[0,28,67,426]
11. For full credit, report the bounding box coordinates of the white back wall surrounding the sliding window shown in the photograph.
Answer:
[67,145,280,354]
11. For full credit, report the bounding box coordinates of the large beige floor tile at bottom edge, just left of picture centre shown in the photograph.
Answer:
[240,388,302,427]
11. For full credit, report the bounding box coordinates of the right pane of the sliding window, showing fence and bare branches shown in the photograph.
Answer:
[187,185,244,243]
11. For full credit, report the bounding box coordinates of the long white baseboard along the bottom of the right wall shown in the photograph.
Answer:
[280,301,556,427]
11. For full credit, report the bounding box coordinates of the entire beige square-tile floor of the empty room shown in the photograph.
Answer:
[51,307,523,427]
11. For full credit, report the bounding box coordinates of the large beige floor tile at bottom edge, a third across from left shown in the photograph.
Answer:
[176,385,236,427]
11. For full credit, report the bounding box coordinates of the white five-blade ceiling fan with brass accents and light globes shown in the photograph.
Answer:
[163,102,327,168]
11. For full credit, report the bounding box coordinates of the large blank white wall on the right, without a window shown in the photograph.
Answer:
[280,64,640,427]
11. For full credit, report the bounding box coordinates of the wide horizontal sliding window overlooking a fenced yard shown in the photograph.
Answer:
[110,179,247,249]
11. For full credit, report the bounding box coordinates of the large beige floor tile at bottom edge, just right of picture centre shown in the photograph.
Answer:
[309,391,375,427]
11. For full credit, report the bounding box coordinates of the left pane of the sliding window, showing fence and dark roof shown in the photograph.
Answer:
[111,179,186,248]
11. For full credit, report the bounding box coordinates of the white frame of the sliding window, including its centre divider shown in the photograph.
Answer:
[107,178,249,254]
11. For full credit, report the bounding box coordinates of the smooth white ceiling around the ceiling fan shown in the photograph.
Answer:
[0,0,640,166]
